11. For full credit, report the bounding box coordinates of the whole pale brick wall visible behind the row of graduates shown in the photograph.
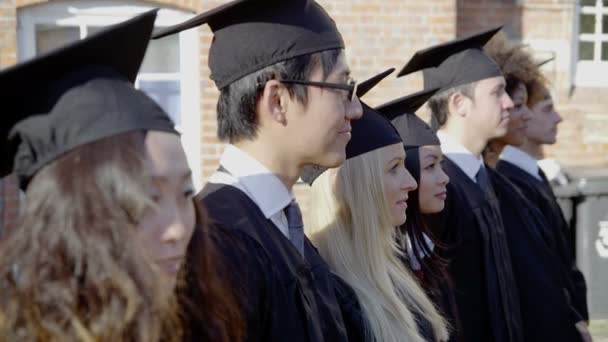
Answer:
[0,0,608,228]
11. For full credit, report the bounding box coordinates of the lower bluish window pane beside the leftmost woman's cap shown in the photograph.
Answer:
[139,81,181,127]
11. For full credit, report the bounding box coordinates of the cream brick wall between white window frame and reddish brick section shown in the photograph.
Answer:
[199,0,456,210]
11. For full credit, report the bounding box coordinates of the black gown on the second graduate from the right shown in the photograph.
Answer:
[488,169,581,342]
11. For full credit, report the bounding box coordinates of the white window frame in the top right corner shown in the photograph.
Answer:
[573,0,608,87]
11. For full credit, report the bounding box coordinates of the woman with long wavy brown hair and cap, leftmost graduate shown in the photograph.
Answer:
[0,11,241,341]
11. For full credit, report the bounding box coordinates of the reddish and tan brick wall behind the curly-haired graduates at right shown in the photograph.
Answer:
[457,0,608,168]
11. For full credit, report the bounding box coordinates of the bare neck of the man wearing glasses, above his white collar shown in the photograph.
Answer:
[233,139,302,191]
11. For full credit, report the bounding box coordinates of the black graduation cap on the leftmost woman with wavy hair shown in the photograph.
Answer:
[0,10,177,190]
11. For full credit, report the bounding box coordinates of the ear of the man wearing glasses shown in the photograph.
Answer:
[257,80,289,125]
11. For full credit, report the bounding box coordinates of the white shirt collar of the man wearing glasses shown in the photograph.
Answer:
[220,145,295,219]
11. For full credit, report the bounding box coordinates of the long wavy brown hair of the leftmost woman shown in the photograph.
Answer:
[0,132,240,341]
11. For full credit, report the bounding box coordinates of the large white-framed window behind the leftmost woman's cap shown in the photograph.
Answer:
[18,0,201,188]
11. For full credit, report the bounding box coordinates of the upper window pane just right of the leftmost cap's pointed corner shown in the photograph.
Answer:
[141,34,179,73]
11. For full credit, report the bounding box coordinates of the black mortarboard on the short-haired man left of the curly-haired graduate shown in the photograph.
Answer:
[397,26,502,92]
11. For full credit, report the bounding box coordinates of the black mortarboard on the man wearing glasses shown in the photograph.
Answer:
[154,0,344,89]
